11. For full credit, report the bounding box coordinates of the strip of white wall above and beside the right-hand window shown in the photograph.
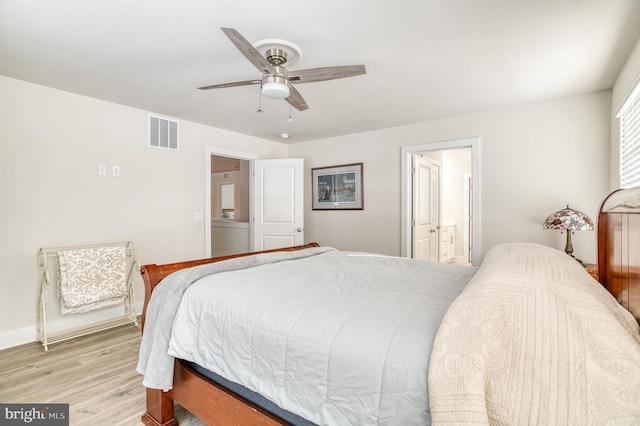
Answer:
[610,36,640,190]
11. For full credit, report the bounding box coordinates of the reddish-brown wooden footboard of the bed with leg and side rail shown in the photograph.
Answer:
[140,243,319,426]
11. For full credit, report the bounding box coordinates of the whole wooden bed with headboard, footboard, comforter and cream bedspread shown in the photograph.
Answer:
[138,190,640,425]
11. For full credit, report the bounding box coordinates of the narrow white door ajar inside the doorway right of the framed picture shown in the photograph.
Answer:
[412,155,440,262]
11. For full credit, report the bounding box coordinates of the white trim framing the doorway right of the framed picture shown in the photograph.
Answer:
[400,137,481,266]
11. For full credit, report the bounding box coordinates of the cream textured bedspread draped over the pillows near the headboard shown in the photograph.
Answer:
[429,244,640,425]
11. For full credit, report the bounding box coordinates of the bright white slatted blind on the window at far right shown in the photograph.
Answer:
[618,82,640,188]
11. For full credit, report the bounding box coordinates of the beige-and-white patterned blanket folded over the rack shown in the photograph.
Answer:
[58,246,127,314]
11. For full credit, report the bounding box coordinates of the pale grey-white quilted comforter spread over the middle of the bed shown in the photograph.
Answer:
[145,251,475,425]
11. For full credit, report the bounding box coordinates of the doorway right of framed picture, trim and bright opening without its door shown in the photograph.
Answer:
[401,138,480,266]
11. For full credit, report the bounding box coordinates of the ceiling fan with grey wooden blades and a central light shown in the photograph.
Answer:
[198,28,366,111]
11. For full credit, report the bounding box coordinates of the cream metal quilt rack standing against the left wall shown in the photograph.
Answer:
[37,241,140,351]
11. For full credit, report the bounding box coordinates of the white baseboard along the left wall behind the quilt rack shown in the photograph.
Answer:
[0,302,143,350]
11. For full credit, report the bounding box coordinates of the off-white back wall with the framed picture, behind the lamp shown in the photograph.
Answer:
[289,91,611,263]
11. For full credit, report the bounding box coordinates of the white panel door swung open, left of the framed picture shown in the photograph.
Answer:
[252,158,304,251]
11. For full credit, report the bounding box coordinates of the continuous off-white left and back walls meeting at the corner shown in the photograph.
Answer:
[0,76,616,348]
